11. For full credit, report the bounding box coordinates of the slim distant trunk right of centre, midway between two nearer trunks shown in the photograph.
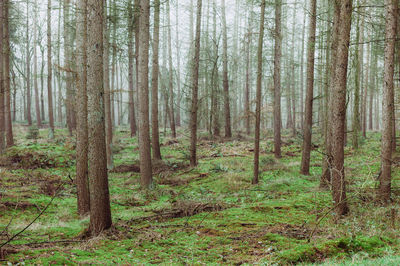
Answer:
[221,0,232,138]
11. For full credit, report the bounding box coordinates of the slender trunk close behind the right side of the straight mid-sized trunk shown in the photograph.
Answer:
[151,0,161,160]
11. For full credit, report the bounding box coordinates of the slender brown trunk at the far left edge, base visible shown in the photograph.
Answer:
[0,0,15,147]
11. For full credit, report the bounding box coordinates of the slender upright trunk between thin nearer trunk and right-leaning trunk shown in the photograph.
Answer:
[274,0,282,158]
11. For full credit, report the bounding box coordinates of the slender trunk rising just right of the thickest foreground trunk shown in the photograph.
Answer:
[103,0,114,170]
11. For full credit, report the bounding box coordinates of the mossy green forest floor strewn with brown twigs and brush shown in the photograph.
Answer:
[0,126,400,265]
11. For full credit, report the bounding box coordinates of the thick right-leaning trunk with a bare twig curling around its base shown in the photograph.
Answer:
[331,0,352,217]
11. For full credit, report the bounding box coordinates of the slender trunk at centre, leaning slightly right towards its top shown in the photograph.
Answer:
[190,0,202,166]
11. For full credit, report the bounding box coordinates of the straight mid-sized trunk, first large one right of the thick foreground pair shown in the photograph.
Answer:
[138,0,153,189]
